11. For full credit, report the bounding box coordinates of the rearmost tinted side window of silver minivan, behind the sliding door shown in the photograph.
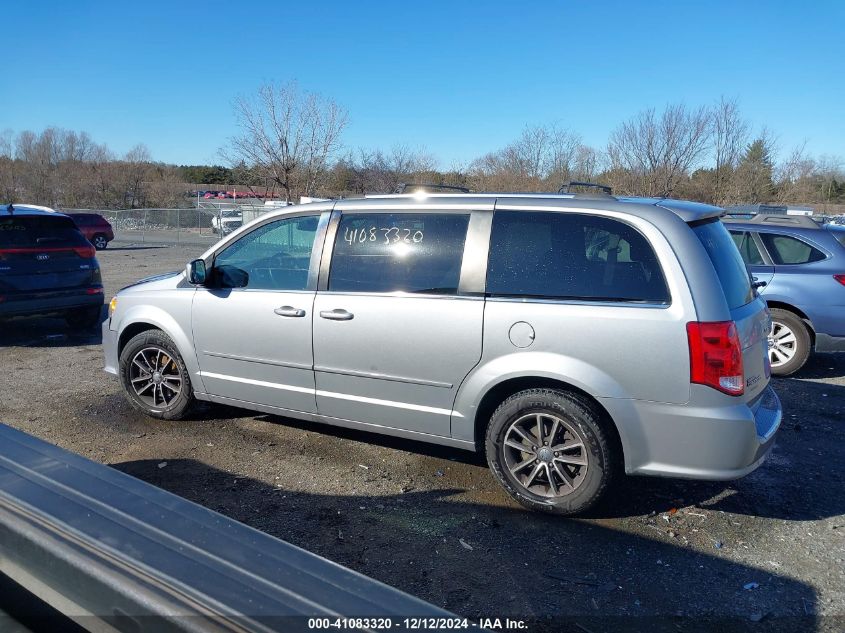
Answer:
[487,211,669,303]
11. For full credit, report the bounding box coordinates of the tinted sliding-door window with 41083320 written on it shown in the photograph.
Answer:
[328,213,469,295]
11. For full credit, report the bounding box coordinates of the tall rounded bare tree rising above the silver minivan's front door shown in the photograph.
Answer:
[223,83,347,201]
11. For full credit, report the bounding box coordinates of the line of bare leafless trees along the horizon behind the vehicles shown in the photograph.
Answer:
[0,83,845,208]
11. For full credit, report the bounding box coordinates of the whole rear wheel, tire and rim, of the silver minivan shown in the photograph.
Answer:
[486,389,619,515]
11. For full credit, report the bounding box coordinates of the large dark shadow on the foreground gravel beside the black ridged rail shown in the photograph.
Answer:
[114,459,816,633]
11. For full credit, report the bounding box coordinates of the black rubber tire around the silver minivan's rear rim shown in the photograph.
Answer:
[485,389,621,515]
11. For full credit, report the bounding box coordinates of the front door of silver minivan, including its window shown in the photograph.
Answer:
[191,213,328,413]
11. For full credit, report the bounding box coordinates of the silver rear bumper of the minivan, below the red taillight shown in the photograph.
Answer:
[601,385,783,480]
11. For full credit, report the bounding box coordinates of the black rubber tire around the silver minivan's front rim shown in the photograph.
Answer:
[119,330,194,420]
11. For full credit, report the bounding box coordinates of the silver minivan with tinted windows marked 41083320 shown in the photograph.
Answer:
[103,193,782,514]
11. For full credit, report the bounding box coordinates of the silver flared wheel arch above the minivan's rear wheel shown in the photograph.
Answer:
[452,352,631,441]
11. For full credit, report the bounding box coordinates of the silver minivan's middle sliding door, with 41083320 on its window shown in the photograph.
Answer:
[314,211,484,436]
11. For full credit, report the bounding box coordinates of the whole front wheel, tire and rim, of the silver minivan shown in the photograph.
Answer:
[120,330,194,420]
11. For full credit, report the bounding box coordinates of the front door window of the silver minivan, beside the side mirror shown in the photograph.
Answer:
[214,216,318,290]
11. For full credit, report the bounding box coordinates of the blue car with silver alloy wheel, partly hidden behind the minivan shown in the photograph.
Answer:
[723,215,845,376]
